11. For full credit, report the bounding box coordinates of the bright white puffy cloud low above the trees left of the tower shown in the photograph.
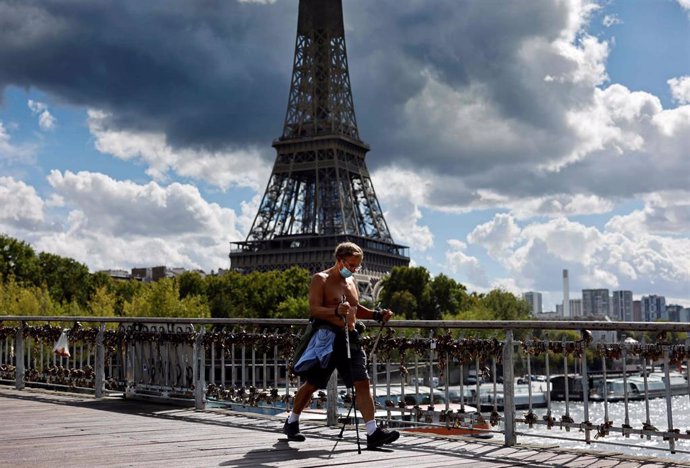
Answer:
[0,170,246,271]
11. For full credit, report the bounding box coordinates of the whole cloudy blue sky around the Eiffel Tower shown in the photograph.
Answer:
[0,0,690,309]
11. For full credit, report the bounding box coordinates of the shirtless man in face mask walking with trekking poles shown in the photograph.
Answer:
[283,242,400,449]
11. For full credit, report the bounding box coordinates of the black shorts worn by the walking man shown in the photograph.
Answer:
[304,330,369,388]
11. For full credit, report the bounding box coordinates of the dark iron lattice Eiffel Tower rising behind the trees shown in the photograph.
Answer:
[230,0,409,289]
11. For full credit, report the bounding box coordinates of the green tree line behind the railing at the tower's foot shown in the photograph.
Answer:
[0,235,529,320]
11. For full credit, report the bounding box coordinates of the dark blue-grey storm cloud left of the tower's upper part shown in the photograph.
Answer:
[0,0,296,147]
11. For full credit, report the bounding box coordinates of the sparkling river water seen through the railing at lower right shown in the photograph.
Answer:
[516,395,690,461]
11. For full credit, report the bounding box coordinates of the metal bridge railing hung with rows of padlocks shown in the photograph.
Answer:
[0,316,690,454]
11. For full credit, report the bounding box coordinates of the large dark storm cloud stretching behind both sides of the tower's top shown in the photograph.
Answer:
[0,0,683,206]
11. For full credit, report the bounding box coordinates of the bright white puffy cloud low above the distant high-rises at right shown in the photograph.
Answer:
[468,214,690,306]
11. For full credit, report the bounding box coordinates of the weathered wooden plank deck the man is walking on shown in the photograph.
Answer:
[0,386,690,468]
